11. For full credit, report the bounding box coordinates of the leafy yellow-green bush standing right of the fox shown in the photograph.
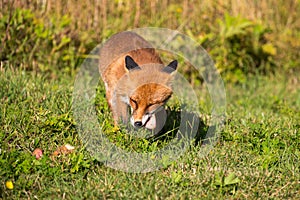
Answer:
[211,14,276,82]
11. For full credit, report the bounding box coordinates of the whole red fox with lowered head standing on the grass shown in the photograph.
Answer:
[99,31,177,129]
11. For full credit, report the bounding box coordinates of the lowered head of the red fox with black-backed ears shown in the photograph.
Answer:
[116,56,177,129]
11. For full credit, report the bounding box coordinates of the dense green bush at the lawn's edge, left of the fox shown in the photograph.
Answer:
[0,8,83,74]
